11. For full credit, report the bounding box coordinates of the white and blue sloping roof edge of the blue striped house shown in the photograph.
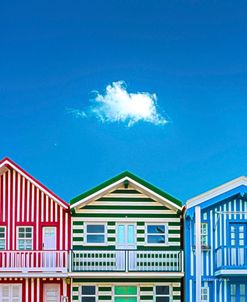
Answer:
[186,176,247,209]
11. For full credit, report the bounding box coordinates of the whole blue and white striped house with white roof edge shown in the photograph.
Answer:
[184,177,247,302]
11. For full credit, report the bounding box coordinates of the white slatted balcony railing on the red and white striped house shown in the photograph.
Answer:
[0,251,68,273]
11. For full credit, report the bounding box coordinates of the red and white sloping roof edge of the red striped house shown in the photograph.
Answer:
[0,157,69,209]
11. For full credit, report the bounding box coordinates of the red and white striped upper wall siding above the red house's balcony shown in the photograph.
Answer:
[0,169,70,250]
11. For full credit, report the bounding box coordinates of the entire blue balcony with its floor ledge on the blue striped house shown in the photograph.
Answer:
[216,246,247,275]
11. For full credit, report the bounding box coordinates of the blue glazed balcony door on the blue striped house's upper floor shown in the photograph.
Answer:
[230,223,247,266]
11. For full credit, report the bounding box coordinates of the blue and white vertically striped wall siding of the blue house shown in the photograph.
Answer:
[186,196,247,302]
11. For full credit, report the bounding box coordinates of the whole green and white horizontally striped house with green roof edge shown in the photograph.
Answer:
[70,172,184,302]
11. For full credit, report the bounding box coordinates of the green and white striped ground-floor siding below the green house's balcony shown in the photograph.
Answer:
[72,279,182,302]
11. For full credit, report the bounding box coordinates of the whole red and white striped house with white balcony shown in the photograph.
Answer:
[0,158,71,302]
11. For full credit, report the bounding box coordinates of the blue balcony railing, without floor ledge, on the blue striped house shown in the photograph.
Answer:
[216,246,247,270]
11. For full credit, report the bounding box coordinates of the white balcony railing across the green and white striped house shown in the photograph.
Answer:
[71,250,183,272]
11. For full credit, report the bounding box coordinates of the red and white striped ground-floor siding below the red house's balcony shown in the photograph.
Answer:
[0,278,70,302]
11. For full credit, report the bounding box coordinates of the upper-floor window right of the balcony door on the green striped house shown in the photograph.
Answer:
[146,224,168,244]
